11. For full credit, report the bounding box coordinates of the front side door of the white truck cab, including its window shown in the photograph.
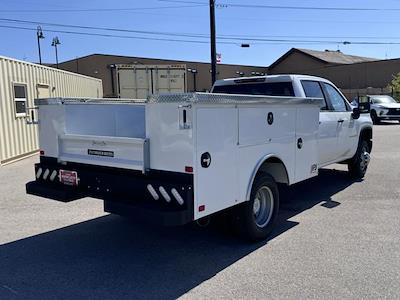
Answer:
[321,82,357,160]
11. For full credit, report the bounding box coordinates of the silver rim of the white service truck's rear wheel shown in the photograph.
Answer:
[253,186,274,228]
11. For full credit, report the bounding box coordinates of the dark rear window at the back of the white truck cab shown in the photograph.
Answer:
[213,82,294,97]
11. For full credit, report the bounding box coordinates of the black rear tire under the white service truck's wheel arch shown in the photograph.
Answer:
[234,173,279,241]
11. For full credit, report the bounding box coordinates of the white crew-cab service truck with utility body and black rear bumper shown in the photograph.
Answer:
[26,75,372,240]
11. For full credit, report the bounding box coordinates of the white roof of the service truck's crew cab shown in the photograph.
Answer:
[214,74,329,86]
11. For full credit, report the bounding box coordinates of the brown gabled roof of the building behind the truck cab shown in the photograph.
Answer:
[270,48,379,68]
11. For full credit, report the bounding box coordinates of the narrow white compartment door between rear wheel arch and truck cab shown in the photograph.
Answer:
[295,105,319,182]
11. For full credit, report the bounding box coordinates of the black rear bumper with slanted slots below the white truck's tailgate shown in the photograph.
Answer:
[26,157,194,225]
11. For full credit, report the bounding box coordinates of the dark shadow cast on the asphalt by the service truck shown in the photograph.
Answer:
[0,170,352,299]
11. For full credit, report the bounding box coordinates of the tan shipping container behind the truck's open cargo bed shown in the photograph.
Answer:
[115,64,187,99]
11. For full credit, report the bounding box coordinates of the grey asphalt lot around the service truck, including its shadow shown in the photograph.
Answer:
[0,123,400,299]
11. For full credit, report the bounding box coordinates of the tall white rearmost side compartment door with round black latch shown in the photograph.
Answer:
[194,107,238,219]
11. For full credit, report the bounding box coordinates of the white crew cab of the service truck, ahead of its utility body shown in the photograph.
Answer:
[212,75,372,172]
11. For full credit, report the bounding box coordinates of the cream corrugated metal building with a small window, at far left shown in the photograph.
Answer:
[0,56,103,165]
